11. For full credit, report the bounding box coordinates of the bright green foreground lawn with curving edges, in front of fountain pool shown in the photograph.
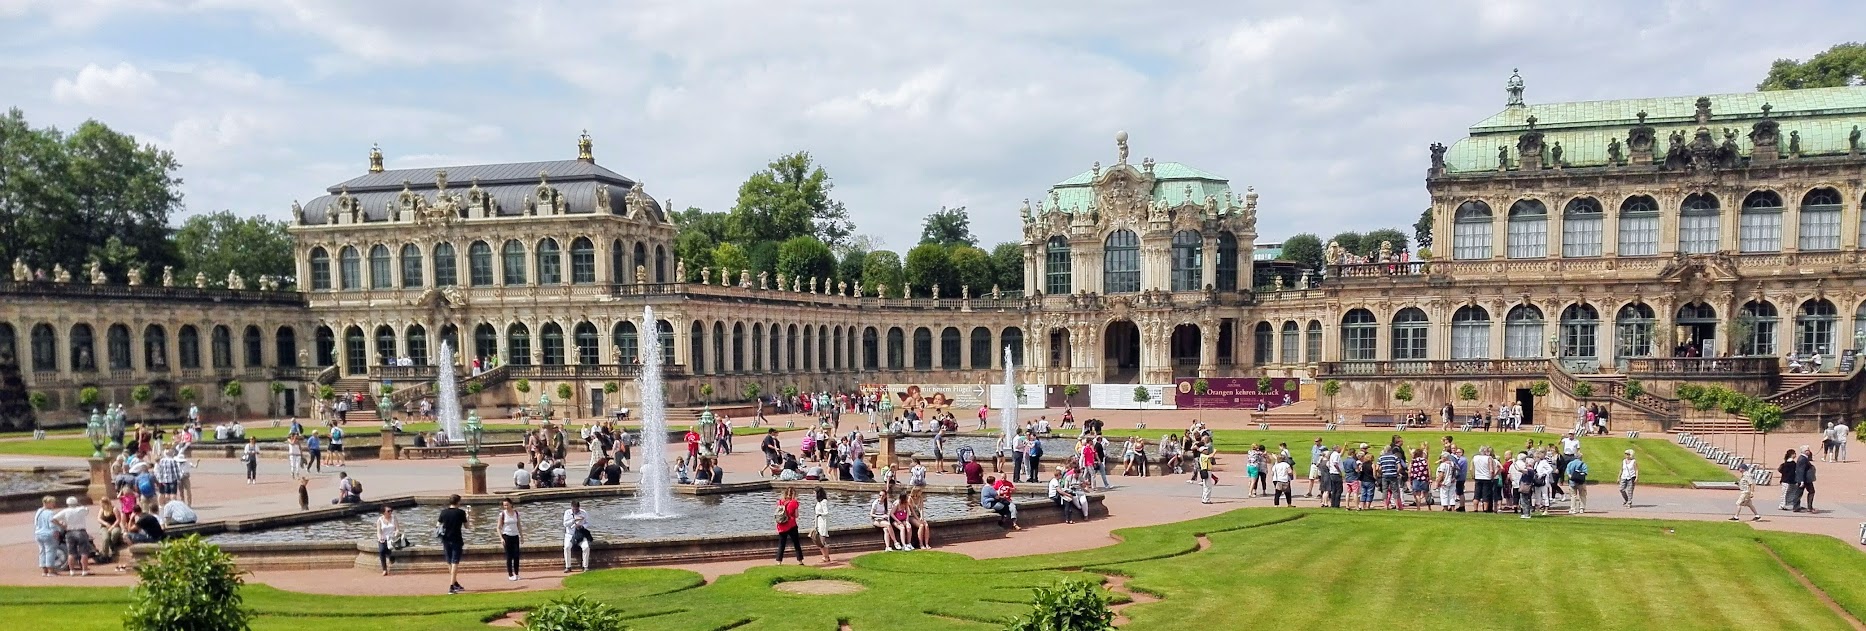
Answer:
[0,508,1866,631]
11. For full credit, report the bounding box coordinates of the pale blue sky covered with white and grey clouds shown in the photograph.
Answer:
[0,0,1866,250]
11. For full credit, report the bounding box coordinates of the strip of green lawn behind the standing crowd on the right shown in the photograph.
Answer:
[1108,429,1735,487]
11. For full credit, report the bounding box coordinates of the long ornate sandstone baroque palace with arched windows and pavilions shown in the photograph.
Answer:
[0,77,1866,428]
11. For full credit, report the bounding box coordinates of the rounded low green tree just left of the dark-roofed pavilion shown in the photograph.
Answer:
[175,211,297,287]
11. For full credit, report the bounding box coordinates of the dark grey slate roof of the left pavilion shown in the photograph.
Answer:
[302,161,668,224]
